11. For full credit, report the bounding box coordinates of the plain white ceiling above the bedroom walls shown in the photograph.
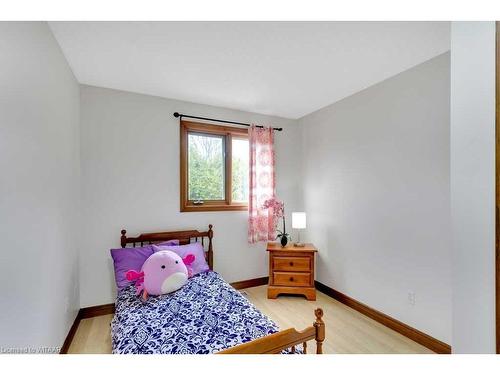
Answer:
[50,22,450,119]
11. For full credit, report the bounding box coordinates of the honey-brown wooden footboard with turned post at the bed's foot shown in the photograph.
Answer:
[217,308,325,354]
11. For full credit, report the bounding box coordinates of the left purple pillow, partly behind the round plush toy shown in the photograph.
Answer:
[110,245,154,290]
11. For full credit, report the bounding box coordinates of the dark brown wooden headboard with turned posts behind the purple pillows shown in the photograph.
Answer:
[120,224,214,270]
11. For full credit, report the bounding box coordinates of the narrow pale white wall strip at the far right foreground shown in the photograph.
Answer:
[451,22,495,353]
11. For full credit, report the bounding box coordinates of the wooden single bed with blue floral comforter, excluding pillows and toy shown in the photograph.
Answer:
[111,225,325,354]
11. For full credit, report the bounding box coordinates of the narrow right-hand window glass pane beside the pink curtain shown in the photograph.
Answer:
[231,138,249,202]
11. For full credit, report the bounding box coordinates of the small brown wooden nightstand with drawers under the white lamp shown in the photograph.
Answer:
[267,242,318,301]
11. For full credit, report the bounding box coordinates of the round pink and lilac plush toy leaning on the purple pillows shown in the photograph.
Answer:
[126,250,195,299]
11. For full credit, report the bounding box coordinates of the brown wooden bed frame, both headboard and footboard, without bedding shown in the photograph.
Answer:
[120,224,325,354]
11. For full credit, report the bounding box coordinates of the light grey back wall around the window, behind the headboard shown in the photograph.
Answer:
[80,86,301,307]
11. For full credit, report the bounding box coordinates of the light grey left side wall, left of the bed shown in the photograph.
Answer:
[0,22,80,348]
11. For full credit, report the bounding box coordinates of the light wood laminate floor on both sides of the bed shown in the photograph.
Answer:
[69,286,432,353]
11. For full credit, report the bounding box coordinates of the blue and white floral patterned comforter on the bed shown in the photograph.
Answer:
[111,271,278,354]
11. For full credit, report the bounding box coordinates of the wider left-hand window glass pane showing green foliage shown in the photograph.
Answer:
[188,133,225,201]
